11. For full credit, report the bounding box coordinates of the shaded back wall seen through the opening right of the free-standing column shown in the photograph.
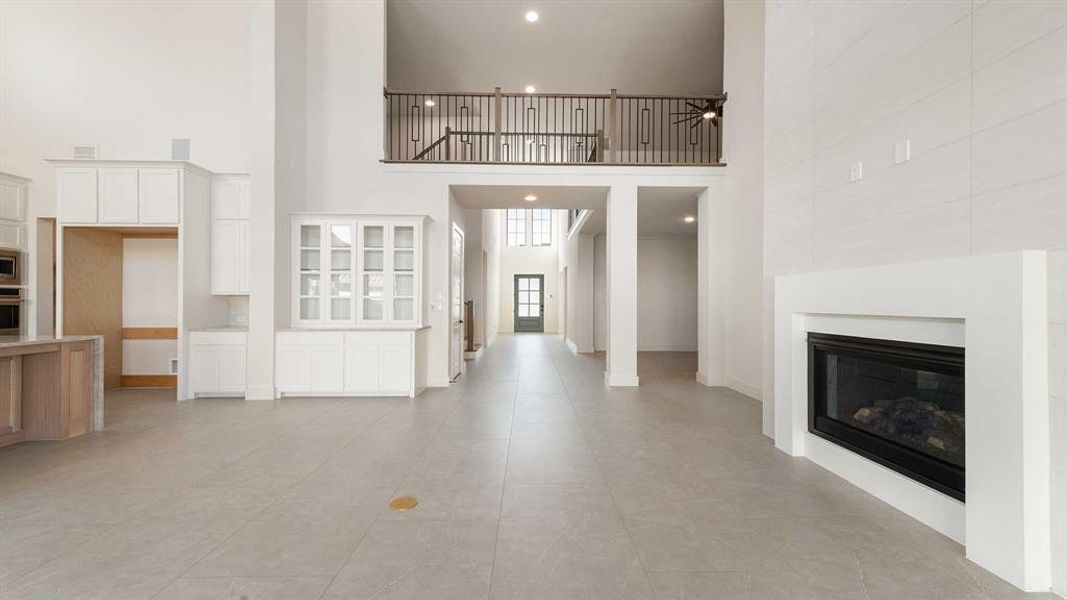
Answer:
[637,237,697,352]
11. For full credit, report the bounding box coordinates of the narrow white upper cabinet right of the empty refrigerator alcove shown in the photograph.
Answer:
[211,175,252,295]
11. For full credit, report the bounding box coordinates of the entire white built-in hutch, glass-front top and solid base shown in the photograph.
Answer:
[275,215,428,396]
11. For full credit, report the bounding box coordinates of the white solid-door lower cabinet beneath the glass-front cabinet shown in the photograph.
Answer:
[275,330,423,396]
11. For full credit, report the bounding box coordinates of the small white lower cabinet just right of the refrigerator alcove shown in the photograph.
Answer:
[189,331,248,397]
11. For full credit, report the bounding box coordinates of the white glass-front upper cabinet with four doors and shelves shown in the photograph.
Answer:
[293,217,425,328]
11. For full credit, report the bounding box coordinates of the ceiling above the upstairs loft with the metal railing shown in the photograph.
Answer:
[387,0,722,95]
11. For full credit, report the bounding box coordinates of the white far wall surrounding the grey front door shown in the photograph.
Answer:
[497,210,560,333]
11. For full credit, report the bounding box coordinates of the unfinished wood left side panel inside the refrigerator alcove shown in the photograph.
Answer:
[63,227,123,389]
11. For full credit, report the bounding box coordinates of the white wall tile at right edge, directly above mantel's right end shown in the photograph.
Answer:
[973,175,1067,254]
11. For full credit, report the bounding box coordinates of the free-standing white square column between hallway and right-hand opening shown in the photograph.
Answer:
[604,186,638,388]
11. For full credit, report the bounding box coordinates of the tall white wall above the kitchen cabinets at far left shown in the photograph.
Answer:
[0,0,251,337]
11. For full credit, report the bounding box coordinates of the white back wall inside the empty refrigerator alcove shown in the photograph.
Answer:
[123,238,178,375]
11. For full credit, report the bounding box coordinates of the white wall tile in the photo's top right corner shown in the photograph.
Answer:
[974,0,1067,68]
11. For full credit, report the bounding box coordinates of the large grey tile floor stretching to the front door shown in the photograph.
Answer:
[0,334,1051,600]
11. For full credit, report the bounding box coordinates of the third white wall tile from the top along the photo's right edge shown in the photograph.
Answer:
[974,100,1067,194]
